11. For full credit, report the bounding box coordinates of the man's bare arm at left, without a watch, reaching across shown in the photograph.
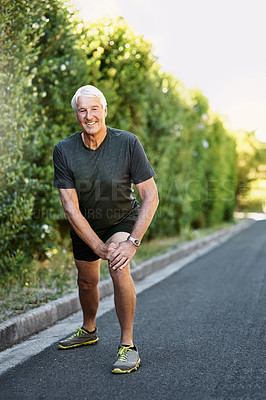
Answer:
[59,189,117,260]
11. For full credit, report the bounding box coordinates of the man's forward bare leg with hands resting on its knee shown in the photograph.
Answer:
[107,232,136,345]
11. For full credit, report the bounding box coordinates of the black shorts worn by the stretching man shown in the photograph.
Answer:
[71,221,135,261]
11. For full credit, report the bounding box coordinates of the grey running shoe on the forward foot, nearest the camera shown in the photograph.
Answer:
[112,346,140,374]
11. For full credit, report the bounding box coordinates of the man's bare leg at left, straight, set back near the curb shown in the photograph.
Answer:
[75,260,100,332]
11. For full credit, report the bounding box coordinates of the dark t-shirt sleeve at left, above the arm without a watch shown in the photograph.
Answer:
[53,144,75,189]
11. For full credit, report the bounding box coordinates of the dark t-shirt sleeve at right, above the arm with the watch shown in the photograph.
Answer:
[130,137,155,185]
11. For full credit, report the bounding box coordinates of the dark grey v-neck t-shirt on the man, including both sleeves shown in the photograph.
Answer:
[54,127,155,232]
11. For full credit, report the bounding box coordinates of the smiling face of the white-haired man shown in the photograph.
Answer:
[76,96,107,136]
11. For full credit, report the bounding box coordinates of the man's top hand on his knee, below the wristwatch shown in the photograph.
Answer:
[109,240,136,271]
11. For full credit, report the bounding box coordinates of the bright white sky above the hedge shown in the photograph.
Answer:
[73,0,266,142]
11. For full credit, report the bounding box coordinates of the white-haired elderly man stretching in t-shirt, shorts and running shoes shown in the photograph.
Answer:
[54,85,158,373]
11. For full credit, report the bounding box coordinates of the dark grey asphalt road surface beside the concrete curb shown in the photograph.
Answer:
[0,221,266,400]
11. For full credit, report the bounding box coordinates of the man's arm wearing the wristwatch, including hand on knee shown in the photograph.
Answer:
[109,178,159,270]
